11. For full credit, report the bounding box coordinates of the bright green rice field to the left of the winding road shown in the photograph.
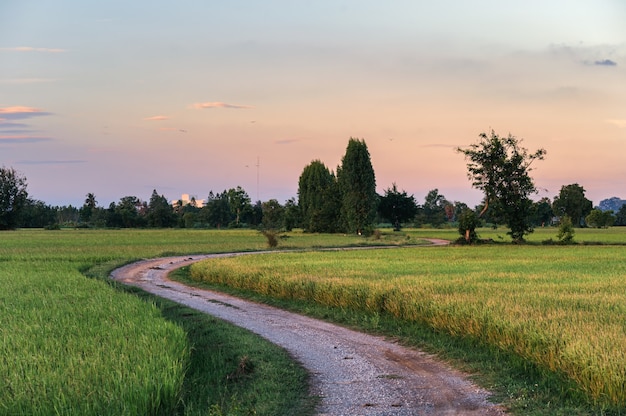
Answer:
[0,230,400,415]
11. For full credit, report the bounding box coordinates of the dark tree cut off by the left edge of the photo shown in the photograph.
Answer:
[0,166,28,230]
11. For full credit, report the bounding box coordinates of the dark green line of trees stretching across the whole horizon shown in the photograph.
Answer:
[0,131,626,234]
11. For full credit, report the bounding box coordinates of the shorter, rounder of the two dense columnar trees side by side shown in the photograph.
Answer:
[298,160,341,233]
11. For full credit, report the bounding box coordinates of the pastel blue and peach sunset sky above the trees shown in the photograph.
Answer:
[0,0,626,207]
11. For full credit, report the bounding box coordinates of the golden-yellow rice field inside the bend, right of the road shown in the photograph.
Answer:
[191,229,626,409]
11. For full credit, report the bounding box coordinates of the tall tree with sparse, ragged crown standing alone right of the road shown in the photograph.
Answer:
[457,130,546,242]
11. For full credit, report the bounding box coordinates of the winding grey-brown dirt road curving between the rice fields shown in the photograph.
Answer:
[111,245,504,416]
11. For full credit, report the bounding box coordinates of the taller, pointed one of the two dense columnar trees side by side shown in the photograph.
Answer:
[337,137,378,235]
